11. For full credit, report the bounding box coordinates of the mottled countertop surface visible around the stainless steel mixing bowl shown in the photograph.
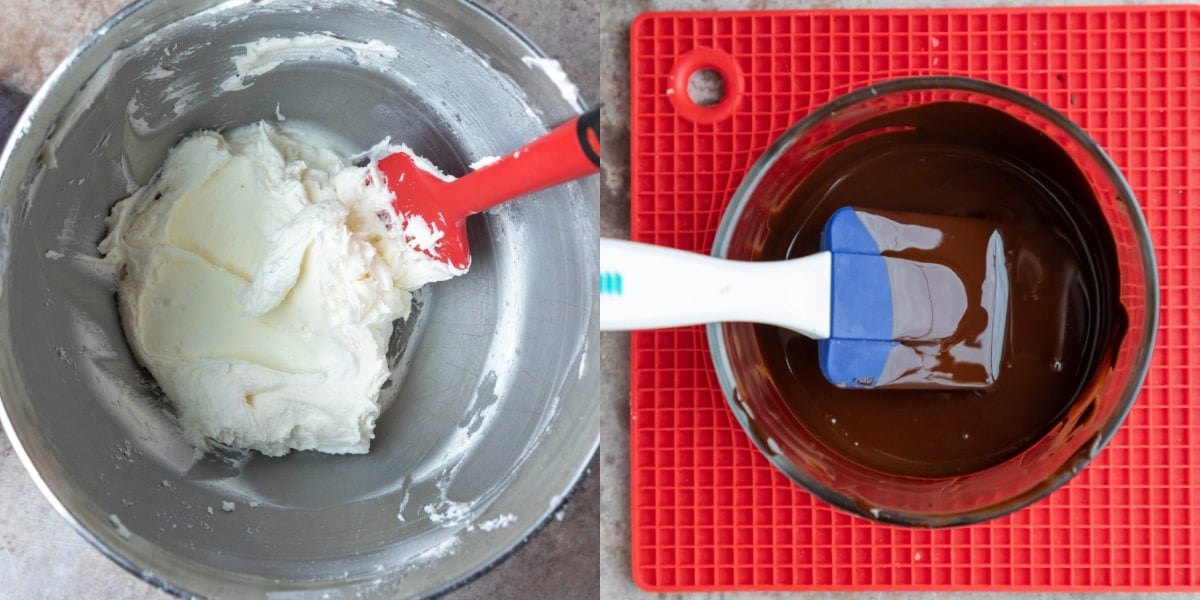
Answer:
[0,0,600,600]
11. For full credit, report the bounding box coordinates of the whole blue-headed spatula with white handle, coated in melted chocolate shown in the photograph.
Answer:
[600,208,1009,389]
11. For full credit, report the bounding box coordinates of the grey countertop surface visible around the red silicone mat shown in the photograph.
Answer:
[600,0,1198,600]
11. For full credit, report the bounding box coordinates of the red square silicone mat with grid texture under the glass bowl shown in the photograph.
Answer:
[630,6,1200,590]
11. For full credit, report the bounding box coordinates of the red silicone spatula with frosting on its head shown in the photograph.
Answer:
[379,108,600,271]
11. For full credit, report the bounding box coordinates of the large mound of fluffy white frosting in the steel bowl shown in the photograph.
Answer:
[100,122,458,456]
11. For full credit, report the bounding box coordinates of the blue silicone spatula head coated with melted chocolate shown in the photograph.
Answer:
[817,208,1009,389]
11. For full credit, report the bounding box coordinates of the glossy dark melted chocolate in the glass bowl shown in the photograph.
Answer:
[755,103,1123,478]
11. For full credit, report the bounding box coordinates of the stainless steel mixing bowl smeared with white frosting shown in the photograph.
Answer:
[0,0,599,598]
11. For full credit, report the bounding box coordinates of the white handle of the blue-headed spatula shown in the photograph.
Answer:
[600,239,830,338]
